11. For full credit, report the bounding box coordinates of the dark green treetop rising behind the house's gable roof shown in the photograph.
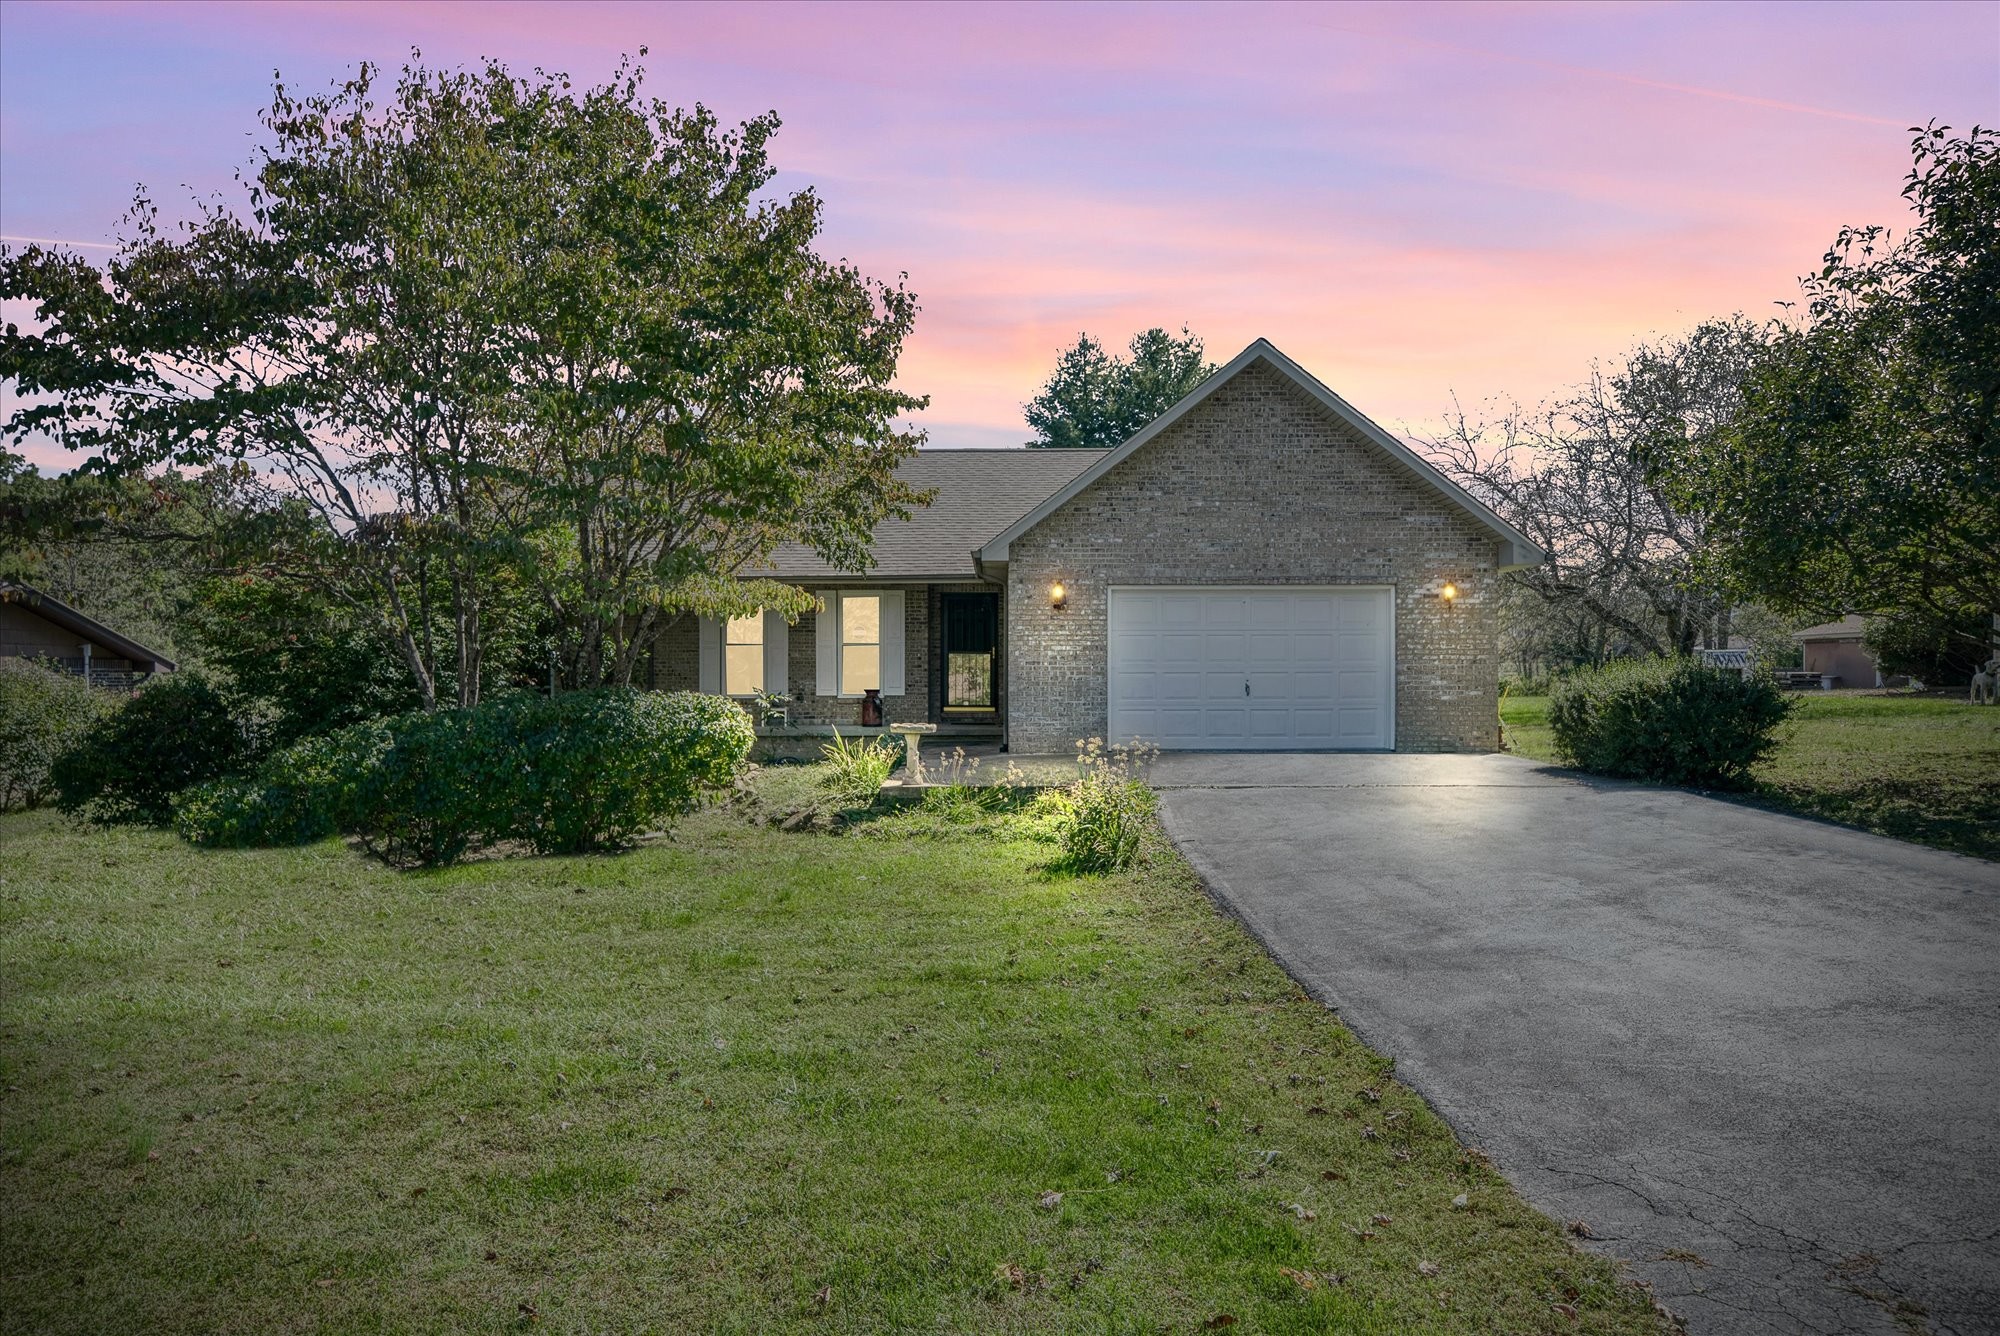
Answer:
[1026,326,1216,450]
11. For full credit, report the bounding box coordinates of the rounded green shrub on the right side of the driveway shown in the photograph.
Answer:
[1548,658,1792,788]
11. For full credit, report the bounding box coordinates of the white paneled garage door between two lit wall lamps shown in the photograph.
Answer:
[1108,586,1396,750]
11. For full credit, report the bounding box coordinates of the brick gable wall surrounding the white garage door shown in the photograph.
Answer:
[1006,362,1498,754]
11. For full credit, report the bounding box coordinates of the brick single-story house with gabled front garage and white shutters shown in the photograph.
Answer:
[650,340,1542,754]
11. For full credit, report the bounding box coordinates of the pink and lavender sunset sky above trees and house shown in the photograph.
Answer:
[0,0,2000,466]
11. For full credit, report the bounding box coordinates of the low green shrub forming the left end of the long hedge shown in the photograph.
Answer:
[174,720,390,848]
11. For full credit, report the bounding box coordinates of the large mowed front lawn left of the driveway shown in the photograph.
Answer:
[0,788,1658,1332]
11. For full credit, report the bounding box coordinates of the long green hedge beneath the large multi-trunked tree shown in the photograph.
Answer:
[174,690,756,866]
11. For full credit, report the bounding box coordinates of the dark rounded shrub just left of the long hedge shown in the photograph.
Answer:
[50,672,252,826]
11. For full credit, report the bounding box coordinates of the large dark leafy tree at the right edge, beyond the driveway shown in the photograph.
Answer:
[1646,126,2000,656]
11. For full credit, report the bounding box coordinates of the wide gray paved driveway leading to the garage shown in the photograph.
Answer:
[1154,754,2000,1332]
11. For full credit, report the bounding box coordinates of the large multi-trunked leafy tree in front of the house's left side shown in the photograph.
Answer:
[0,54,922,708]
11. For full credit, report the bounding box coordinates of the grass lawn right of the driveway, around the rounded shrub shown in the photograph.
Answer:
[1500,692,2000,858]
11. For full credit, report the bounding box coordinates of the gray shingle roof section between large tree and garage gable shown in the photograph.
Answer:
[746,450,1106,580]
